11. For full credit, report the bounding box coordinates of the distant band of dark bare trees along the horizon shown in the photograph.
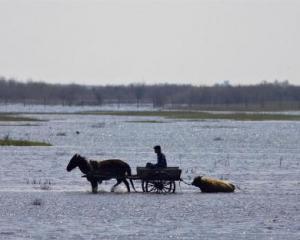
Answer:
[0,77,300,110]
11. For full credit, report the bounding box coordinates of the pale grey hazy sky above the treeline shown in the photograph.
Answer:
[0,0,300,86]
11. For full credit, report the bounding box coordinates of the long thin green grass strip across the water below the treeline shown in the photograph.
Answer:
[79,111,300,122]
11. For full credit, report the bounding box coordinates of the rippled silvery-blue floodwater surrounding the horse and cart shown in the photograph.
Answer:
[0,106,300,240]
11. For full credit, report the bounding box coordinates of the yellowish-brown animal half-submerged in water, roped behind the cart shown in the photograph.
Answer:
[192,176,235,193]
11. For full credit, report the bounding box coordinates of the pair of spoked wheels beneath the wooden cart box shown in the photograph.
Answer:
[144,180,176,193]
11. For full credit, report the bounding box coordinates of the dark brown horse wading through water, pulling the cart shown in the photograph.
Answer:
[67,154,136,193]
